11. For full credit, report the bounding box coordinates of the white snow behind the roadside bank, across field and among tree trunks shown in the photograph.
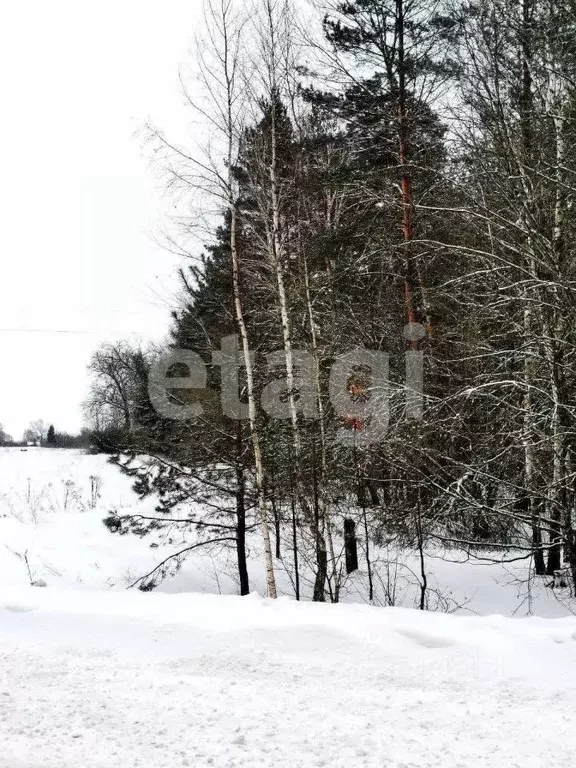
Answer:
[0,448,573,617]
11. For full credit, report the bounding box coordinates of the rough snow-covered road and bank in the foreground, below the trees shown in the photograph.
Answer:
[0,588,576,768]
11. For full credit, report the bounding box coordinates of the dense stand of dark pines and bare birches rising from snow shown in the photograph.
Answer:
[89,0,576,608]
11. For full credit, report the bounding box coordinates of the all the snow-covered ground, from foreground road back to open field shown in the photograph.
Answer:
[0,449,576,768]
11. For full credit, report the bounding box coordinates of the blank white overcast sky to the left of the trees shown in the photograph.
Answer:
[0,0,207,437]
